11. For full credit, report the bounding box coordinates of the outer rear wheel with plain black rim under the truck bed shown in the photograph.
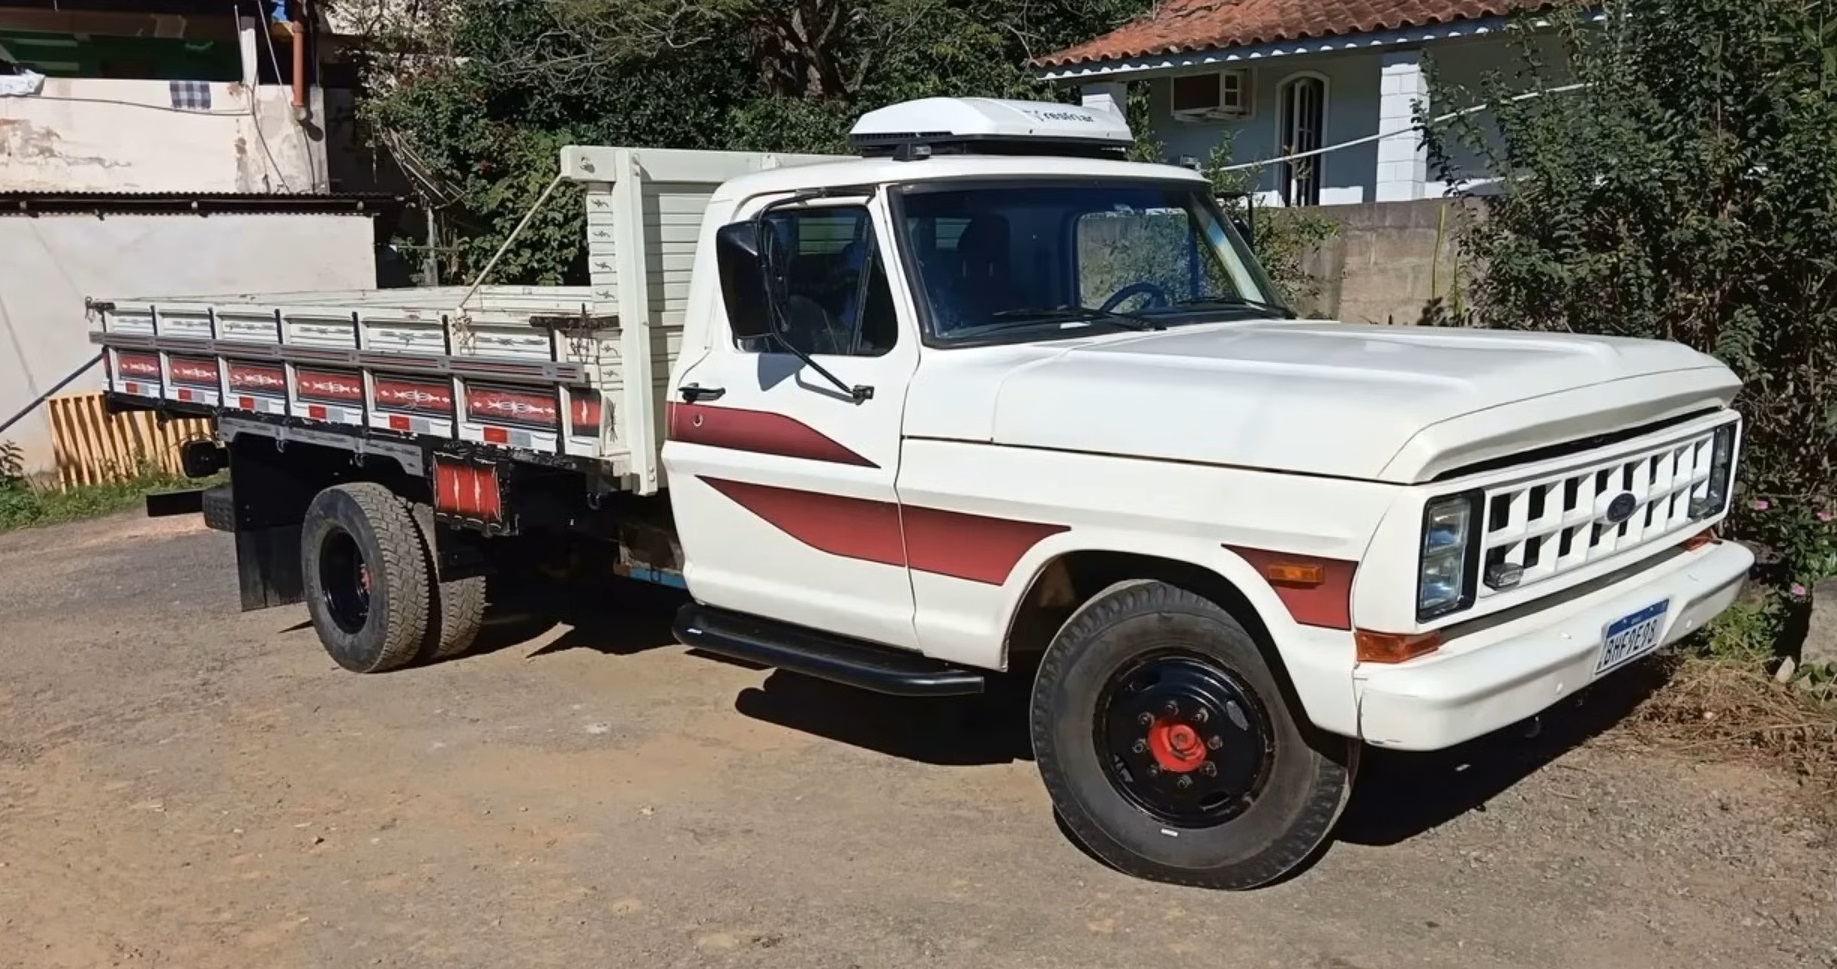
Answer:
[299,482,430,673]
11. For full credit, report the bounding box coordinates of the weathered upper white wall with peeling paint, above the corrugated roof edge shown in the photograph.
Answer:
[0,77,327,193]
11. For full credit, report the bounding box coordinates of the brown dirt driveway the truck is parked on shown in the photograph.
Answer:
[0,519,1837,969]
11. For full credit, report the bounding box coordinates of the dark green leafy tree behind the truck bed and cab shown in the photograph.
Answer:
[361,0,1148,283]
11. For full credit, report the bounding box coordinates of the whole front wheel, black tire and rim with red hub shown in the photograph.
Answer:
[1031,581,1358,890]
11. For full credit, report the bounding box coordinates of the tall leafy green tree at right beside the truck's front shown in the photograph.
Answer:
[1429,0,1837,585]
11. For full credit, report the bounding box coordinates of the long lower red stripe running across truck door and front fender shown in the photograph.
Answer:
[702,478,1065,585]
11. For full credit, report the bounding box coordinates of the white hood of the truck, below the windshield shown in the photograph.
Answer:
[907,322,1740,482]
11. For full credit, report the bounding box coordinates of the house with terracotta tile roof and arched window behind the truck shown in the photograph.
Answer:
[1034,0,1549,204]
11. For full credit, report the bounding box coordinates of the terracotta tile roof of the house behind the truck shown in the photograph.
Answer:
[1034,0,1549,68]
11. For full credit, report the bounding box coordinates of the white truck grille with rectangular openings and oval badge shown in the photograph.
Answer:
[1477,428,1716,599]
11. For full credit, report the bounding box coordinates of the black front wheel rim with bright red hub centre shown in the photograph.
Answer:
[1093,651,1275,827]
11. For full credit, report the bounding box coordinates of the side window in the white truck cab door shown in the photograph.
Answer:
[738,206,898,357]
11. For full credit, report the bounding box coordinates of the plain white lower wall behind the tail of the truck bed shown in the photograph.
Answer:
[0,215,377,469]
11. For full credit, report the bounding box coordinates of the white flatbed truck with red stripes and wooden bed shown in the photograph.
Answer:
[90,99,1752,888]
